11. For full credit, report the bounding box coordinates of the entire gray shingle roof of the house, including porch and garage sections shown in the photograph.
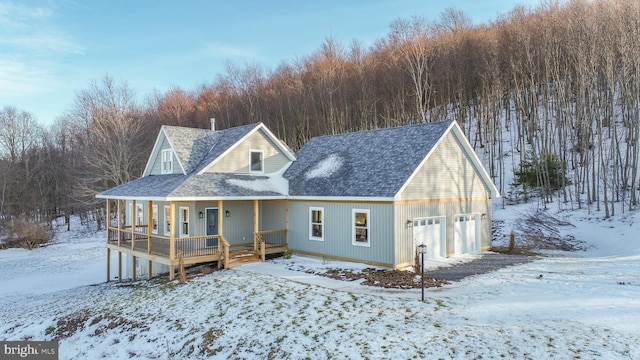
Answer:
[99,121,452,198]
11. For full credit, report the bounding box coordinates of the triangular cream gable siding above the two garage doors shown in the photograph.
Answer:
[400,131,490,200]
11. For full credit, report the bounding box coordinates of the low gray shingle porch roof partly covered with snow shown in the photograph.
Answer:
[96,173,287,200]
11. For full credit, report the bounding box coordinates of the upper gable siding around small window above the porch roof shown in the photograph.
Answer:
[207,130,289,174]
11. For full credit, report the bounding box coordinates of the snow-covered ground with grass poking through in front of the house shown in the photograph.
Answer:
[0,204,640,359]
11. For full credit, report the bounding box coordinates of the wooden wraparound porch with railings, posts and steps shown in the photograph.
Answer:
[106,199,288,281]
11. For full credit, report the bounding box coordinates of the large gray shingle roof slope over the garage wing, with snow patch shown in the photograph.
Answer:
[284,121,452,197]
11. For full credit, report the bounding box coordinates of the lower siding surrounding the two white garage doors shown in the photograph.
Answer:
[395,199,491,266]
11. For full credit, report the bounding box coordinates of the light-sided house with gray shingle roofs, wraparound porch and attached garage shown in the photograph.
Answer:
[97,121,499,279]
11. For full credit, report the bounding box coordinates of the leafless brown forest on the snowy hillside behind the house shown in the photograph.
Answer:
[0,0,640,233]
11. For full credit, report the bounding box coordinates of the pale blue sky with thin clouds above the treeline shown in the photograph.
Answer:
[0,0,538,125]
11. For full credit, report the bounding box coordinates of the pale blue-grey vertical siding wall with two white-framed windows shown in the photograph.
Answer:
[289,200,394,266]
